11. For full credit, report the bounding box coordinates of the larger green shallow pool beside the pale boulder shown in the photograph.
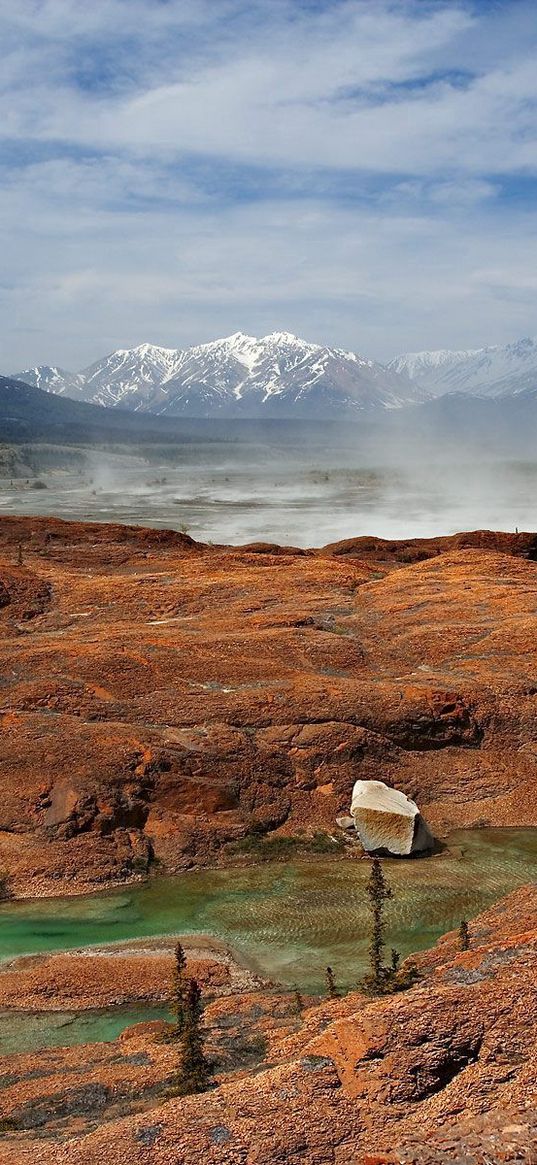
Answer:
[0,829,537,991]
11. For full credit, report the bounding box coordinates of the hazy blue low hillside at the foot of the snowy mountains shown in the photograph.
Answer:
[0,376,537,463]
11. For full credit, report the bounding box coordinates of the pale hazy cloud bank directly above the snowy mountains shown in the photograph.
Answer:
[0,188,537,369]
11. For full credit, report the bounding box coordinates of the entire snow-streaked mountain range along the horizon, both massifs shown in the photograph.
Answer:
[10,332,537,421]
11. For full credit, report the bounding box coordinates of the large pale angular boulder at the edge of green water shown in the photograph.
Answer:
[351,781,434,857]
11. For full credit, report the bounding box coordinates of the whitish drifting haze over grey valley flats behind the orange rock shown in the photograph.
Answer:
[0,425,537,546]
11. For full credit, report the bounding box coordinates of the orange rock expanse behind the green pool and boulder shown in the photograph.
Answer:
[0,517,537,895]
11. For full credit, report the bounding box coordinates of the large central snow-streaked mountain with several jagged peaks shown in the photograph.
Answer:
[16,332,428,419]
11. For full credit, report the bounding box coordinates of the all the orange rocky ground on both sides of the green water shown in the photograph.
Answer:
[0,518,537,1165]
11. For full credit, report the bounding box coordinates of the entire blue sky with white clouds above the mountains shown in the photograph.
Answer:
[0,0,537,374]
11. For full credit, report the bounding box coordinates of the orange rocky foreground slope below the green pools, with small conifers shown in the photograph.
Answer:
[0,887,537,1165]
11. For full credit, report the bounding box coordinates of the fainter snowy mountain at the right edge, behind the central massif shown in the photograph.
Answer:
[388,338,537,397]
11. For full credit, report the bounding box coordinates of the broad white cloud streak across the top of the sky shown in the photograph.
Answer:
[5,0,537,174]
